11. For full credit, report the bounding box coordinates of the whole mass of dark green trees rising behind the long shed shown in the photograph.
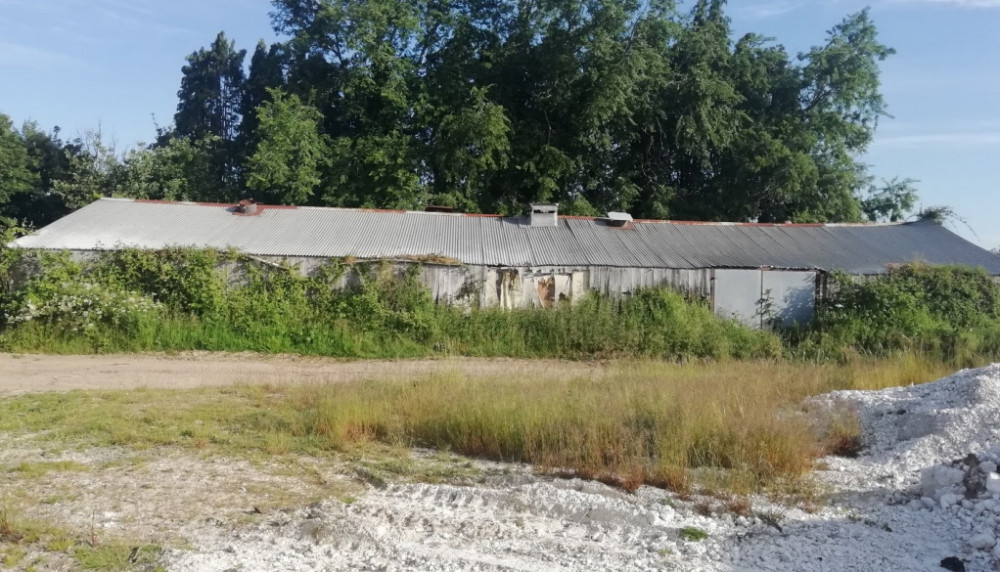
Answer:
[0,0,915,230]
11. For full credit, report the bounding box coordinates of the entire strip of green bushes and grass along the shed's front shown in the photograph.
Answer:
[0,249,1000,366]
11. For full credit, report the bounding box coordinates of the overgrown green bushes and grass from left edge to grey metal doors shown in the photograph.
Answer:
[2,249,782,359]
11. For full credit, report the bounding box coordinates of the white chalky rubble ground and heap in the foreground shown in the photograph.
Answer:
[167,365,1000,572]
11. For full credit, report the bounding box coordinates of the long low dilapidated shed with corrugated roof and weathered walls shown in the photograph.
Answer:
[12,198,1000,326]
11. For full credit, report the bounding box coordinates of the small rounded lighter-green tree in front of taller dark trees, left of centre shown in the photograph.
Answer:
[247,89,326,204]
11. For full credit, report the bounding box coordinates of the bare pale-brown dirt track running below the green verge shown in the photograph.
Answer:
[0,352,607,395]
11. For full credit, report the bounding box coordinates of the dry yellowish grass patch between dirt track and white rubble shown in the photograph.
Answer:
[0,357,949,495]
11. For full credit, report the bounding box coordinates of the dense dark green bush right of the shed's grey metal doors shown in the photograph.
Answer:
[789,264,1000,364]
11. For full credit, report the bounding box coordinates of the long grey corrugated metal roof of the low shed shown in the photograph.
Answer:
[15,199,1000,275]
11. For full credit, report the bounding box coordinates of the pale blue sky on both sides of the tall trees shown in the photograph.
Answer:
[0,0,1000,248]
